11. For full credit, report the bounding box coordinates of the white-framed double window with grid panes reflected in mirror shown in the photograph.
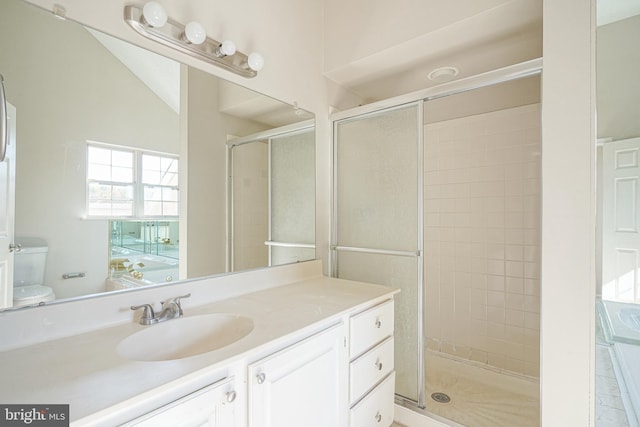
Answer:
[87,143,179,218]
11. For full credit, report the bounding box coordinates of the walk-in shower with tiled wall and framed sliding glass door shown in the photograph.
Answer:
[331,61,541,426]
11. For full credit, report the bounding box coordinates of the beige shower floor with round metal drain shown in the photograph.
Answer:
[426,352,540,427]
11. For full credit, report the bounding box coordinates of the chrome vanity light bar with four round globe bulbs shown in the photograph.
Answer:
[124,1,264,78]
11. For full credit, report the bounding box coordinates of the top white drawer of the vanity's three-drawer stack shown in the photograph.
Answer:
[349,300,394,359]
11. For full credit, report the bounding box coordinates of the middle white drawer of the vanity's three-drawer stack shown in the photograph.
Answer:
[349,337,394,403]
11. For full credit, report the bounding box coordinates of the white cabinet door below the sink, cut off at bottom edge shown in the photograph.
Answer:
[125,378,240,427]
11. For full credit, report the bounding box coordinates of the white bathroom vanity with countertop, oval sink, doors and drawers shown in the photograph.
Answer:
[0,262,397,427]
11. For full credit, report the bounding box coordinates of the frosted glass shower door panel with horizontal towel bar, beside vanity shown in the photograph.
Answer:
[332,104,424,406]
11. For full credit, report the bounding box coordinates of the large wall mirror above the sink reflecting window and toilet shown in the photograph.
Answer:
[0,0,315,310]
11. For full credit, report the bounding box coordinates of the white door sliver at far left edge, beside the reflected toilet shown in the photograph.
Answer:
[0,104,16,308]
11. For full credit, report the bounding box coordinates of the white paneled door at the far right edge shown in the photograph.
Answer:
[602,138,640,303]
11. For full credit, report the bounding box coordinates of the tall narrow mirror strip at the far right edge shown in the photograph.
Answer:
[595,0,640,426]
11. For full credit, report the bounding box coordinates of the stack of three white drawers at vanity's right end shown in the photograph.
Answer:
[349,299,395,427]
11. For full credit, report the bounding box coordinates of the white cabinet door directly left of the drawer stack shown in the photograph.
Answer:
[248,324,348,427]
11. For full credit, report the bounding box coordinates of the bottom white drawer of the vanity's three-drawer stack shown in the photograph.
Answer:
[349,371,396,427]
